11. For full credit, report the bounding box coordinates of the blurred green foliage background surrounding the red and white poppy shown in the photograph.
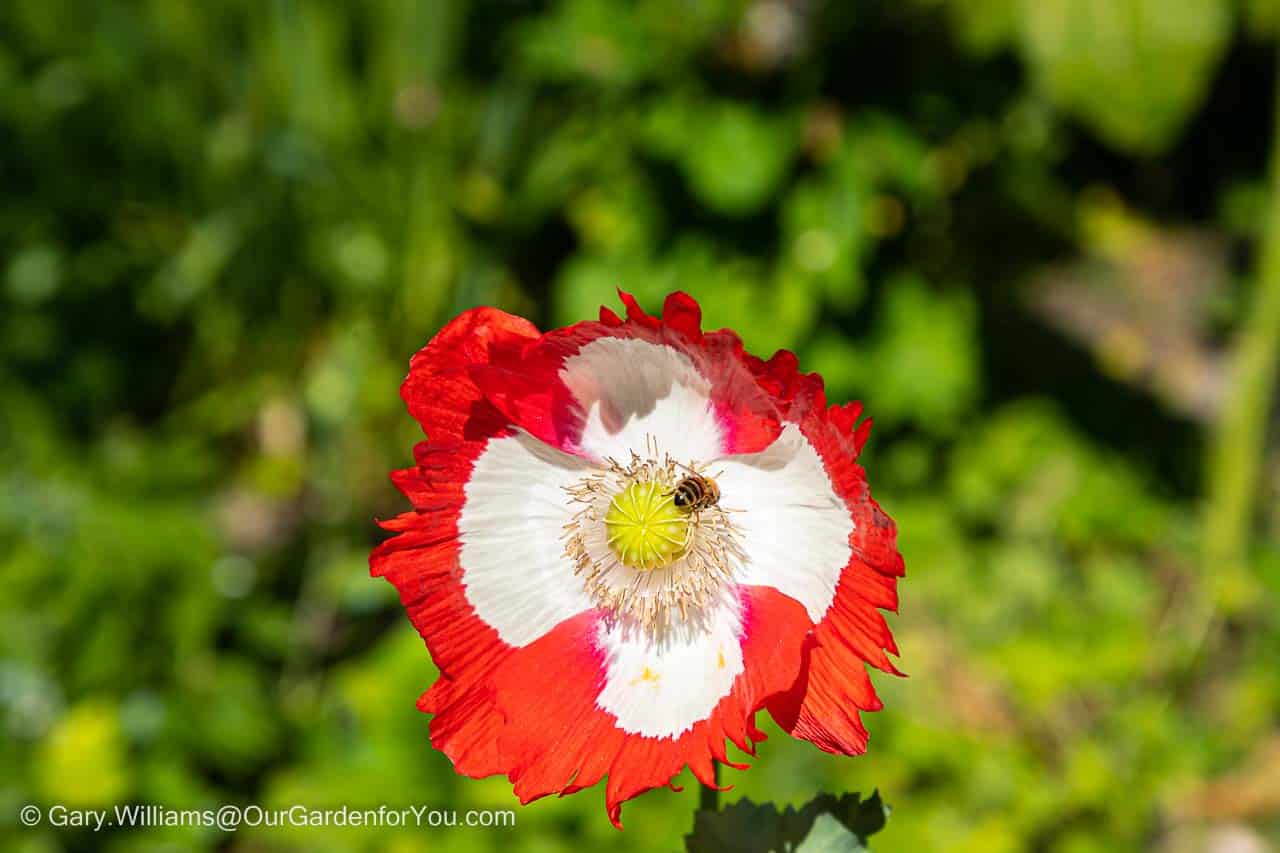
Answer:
[0,0,1280,853]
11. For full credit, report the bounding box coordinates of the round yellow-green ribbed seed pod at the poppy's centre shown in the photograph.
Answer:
[604,480,689,571]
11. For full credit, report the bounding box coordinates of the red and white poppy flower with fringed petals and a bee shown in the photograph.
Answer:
[370,293,904,827]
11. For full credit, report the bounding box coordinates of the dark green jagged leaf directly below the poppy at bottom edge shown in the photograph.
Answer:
[685,792,888,853]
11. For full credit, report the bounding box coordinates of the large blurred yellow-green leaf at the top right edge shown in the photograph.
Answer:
[1023,0,1231,152]
